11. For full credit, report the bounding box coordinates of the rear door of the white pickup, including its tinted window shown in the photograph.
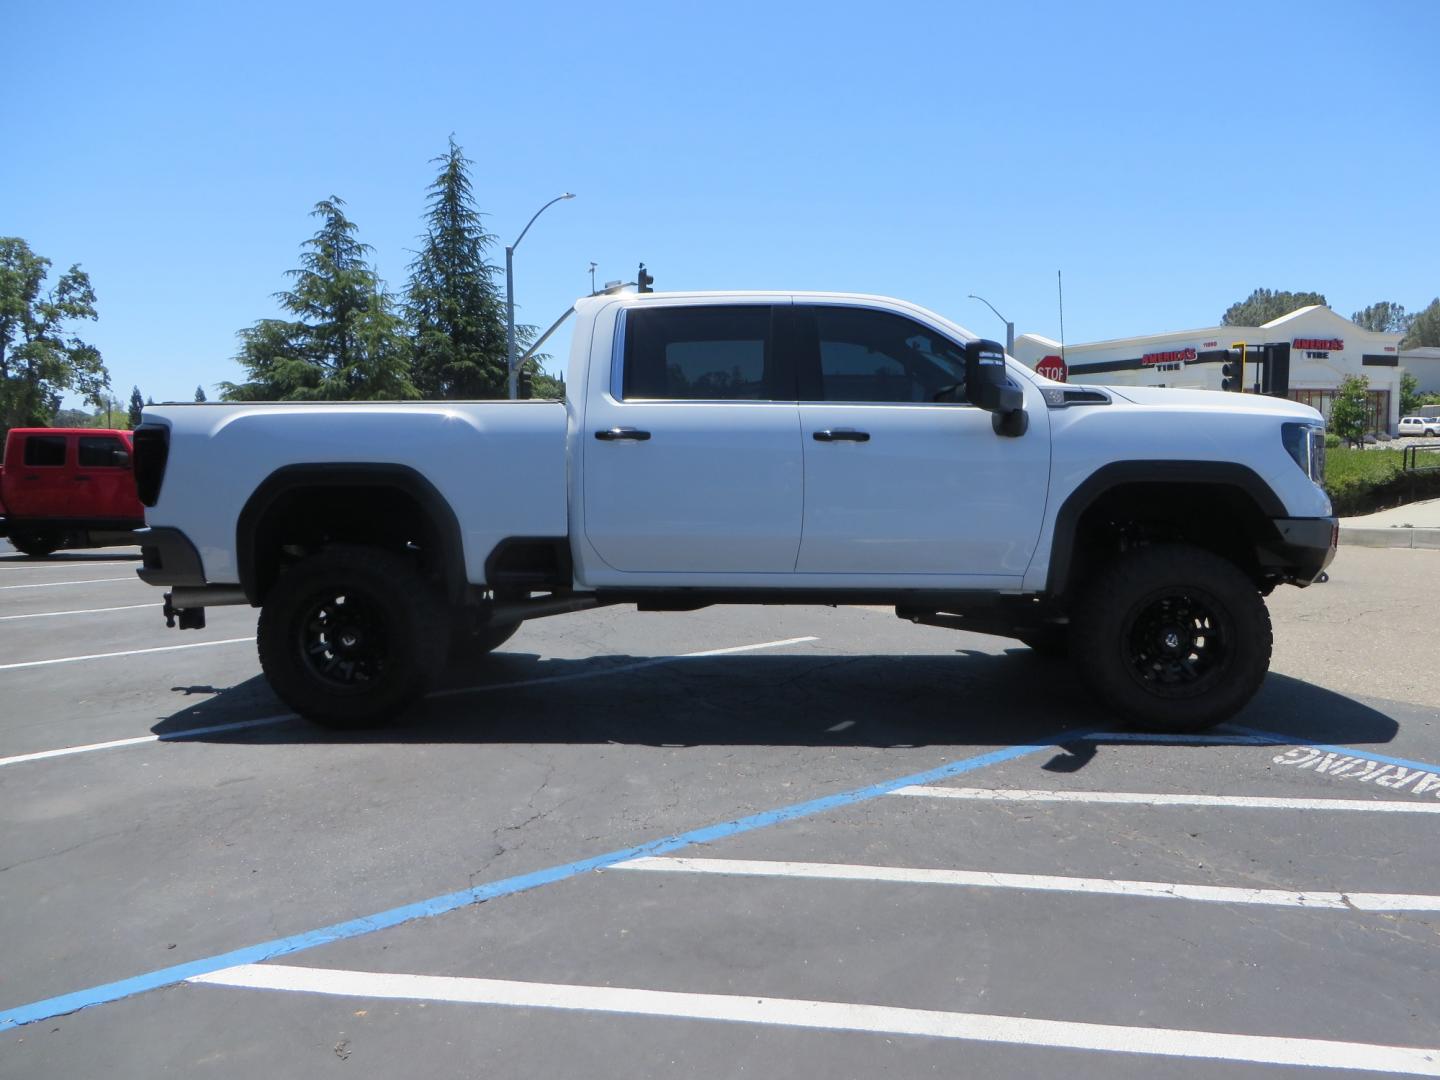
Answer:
[580,302,804,583]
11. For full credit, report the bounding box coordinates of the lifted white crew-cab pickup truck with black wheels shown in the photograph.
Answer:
[135,292,1338,730]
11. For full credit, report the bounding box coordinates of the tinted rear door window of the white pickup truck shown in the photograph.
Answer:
[624,304,777,402]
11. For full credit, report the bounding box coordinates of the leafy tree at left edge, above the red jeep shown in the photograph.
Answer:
[0,236,109,436]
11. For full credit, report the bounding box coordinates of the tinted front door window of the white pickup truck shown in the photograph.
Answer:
[811,307,965,402]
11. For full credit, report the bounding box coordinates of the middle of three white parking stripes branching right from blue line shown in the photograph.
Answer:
[611,857,1440,912]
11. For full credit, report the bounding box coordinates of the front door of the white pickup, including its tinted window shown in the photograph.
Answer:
[795,305,1050,588]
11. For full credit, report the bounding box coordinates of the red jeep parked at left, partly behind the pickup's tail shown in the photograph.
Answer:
[0,428,145,556]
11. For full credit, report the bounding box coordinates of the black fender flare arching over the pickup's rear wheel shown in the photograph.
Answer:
[235,461,467,606]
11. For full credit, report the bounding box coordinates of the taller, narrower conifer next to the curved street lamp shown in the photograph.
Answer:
[406,135,508,399]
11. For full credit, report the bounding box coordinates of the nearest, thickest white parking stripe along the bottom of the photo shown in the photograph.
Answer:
[189,963,1440,1076]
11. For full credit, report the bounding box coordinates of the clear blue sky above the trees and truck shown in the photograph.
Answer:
[0,0,1440,400]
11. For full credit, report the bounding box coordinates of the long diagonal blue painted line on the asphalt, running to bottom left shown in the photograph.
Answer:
[0,730,1087,1031]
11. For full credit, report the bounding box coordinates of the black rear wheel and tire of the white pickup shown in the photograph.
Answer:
[258,546,449,727]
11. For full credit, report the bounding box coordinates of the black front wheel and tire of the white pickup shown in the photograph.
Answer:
[1073,544,1272,732]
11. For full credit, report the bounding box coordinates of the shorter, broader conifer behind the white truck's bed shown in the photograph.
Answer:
[220,196,418,402]
